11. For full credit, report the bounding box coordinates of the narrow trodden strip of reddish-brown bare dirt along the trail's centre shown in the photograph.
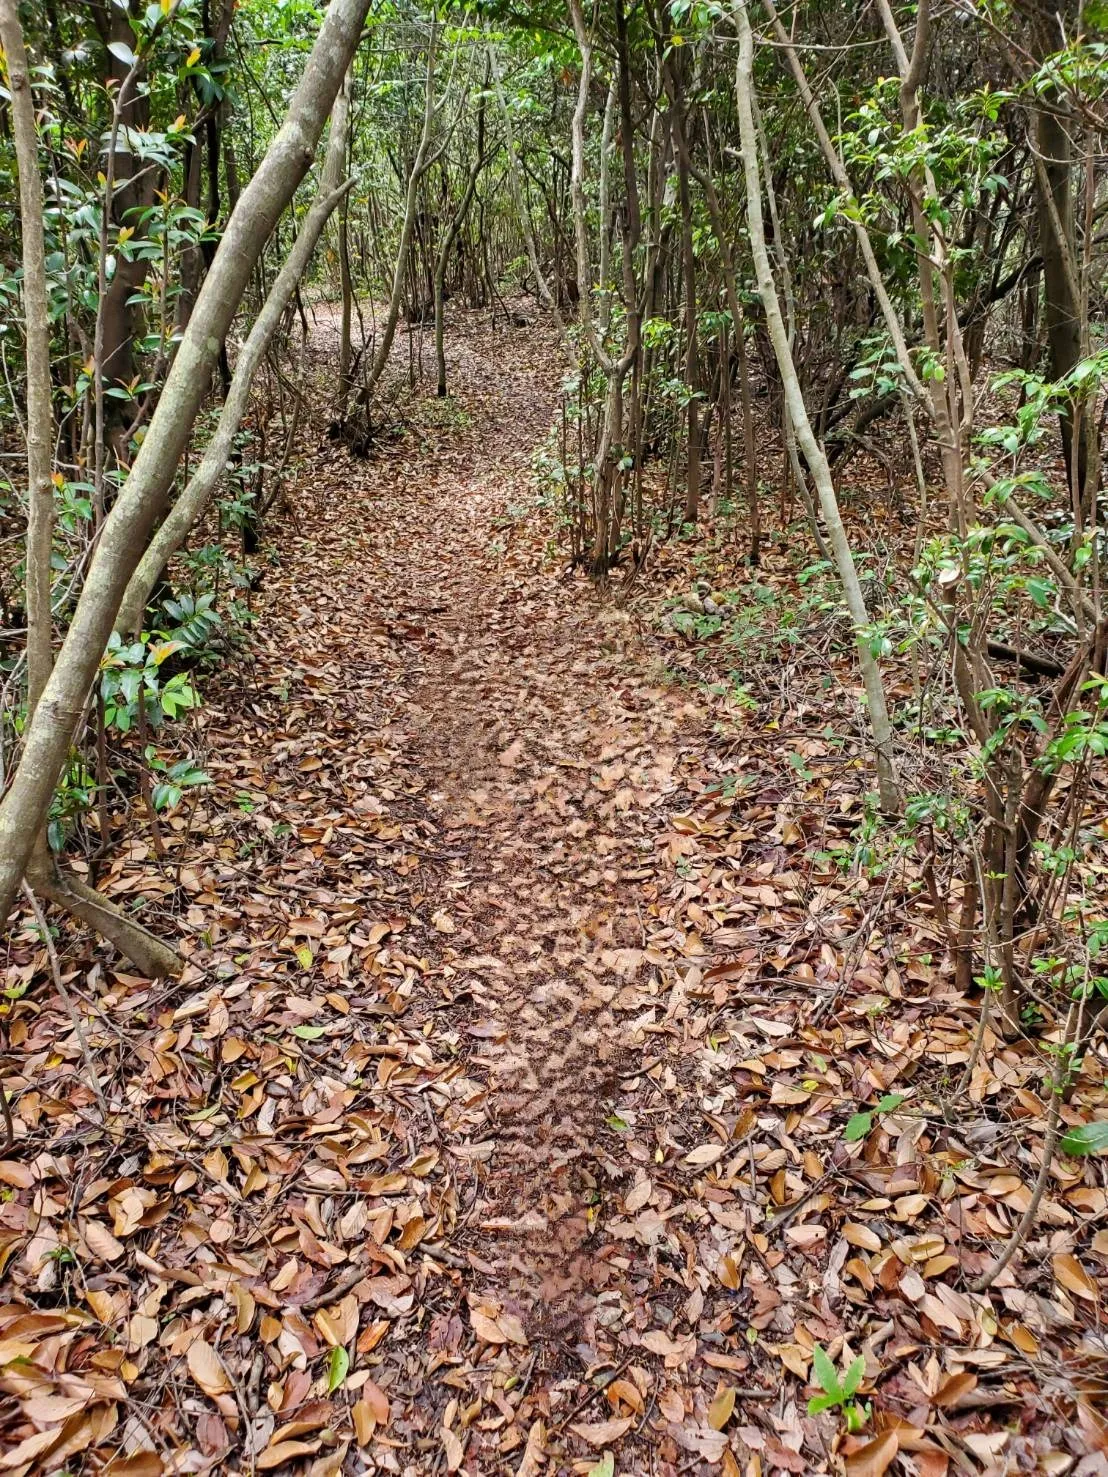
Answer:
[386,344,697,1319]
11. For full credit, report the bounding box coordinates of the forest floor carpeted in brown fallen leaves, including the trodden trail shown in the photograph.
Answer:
[0,315,1108,1477]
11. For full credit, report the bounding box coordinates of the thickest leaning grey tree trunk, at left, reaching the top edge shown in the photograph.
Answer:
[0,0,369,939]
